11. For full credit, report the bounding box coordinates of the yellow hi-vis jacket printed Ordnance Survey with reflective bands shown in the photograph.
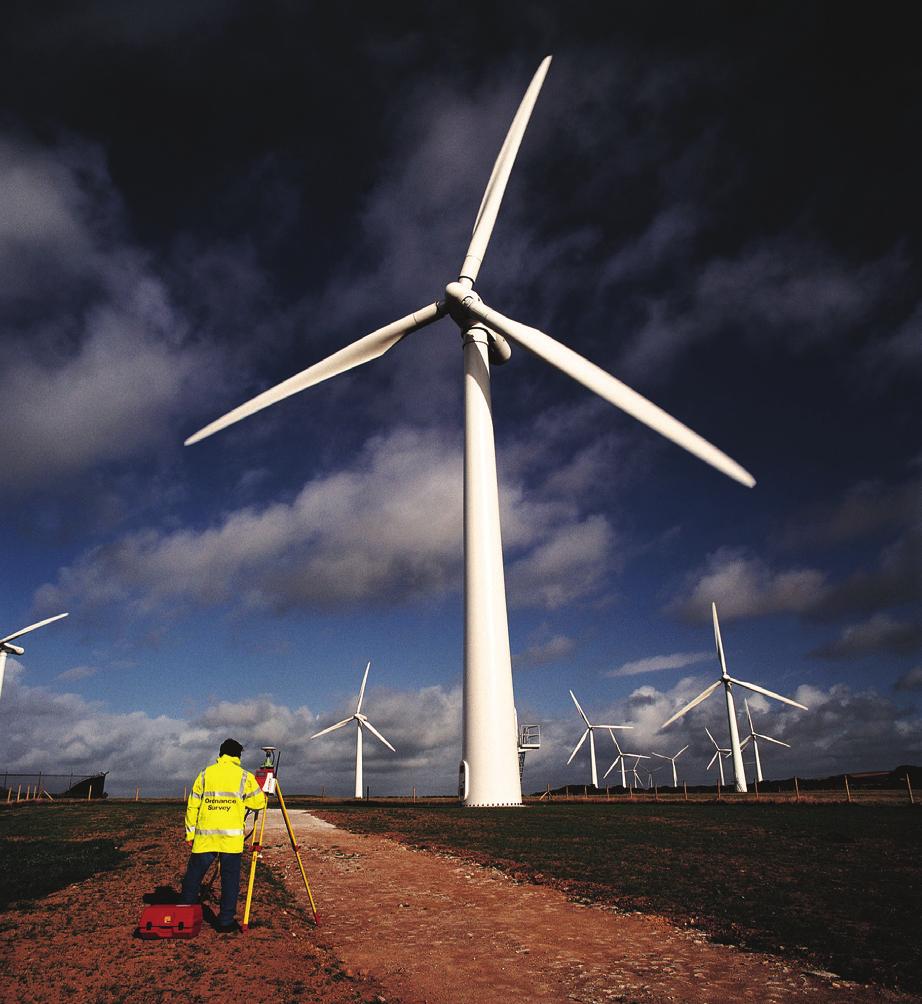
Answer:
[186,756,266,854]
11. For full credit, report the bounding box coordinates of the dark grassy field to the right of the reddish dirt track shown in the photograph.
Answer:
[311,799,922,991]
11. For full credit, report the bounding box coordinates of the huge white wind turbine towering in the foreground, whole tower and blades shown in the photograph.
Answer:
[186,56,755,806]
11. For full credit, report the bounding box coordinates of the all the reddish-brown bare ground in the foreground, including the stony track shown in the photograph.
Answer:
[0,810,920,1004]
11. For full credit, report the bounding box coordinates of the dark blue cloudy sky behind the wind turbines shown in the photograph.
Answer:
[0,0,922,794]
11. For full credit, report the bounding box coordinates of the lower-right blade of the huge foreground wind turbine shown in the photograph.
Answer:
[448,291,755,488]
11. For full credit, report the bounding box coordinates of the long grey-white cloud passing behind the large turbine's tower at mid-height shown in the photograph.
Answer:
[36,421,614,610]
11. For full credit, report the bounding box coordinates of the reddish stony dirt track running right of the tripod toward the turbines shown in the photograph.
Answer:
[266,810,920,1004]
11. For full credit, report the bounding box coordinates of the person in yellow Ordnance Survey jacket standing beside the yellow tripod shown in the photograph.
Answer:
[180,739,266,934]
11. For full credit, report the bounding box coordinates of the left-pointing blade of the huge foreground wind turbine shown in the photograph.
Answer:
[185,303,445,446]
